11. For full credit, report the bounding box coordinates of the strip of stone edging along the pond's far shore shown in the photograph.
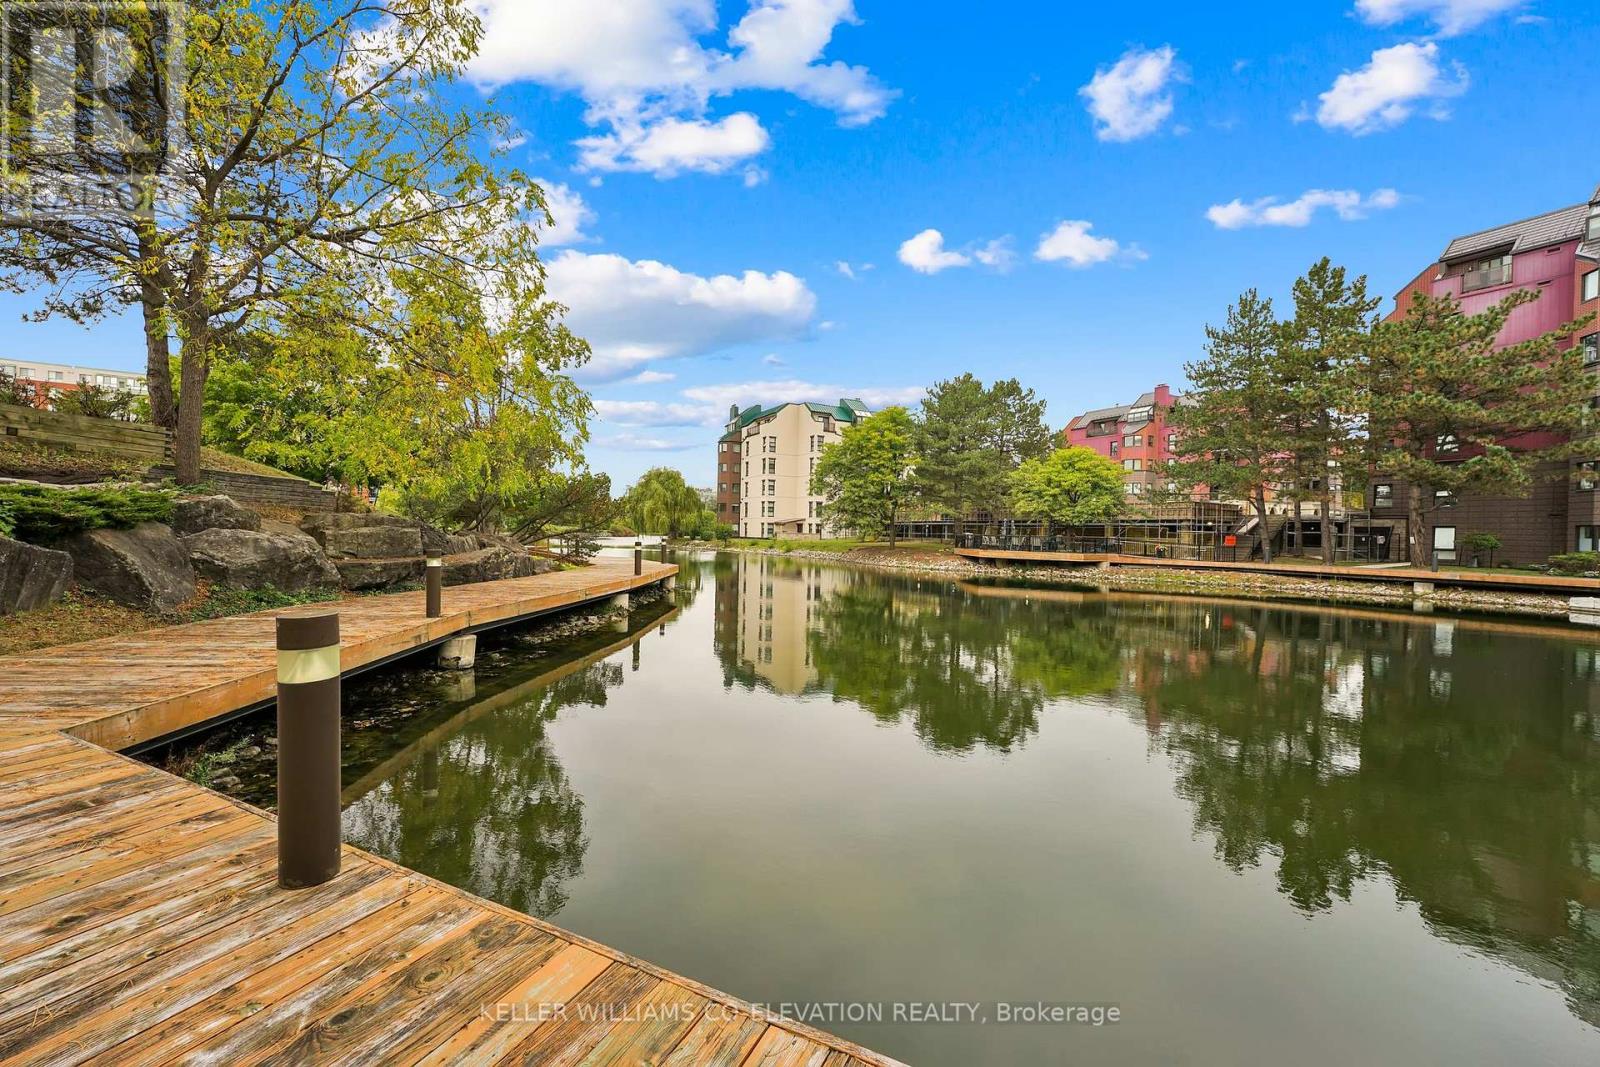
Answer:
[694,544,1568,619]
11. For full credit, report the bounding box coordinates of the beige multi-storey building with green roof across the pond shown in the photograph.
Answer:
[717,397,872,537]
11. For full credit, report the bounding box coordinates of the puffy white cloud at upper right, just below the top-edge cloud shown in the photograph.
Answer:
[1315,42,1469,134]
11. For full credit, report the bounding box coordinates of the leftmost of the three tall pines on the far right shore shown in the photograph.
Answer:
[1163,290,1294,563]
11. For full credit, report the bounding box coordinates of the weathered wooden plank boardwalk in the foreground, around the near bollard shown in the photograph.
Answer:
[0,565,893,1067]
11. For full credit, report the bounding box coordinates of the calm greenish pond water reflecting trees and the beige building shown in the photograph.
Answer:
[328,557,1600,1065]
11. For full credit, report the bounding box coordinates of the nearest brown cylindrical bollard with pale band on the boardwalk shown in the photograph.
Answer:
[278,611,339,889]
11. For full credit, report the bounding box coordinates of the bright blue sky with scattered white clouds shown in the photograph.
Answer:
[0,0,1600,488]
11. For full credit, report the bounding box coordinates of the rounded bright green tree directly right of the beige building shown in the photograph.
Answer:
[811,408,917,547]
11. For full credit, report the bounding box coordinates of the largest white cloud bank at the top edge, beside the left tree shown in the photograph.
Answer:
[470,0,896,182]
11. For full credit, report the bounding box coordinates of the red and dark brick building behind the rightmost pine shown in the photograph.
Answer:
[1371,187,1600,563]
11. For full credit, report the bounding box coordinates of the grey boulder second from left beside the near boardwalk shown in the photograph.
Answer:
[61,523,195,611]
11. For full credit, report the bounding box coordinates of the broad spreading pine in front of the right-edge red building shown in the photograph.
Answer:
[1357,290,1600,566]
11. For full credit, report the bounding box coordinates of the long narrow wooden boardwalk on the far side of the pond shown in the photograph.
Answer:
[955,549,1600,597]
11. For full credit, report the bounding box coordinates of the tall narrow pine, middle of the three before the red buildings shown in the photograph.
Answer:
[1282,256,1382,563]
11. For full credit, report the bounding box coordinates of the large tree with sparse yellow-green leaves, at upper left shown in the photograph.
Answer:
[0,0,558,482]
